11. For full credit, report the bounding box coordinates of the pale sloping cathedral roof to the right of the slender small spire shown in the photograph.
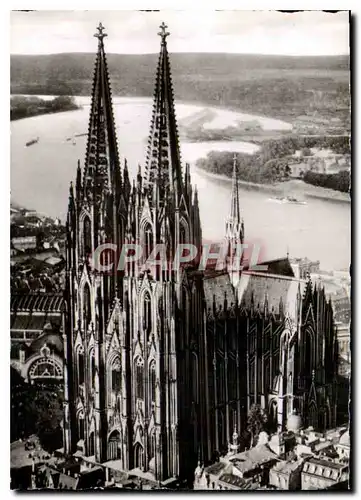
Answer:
[238,271,305,318]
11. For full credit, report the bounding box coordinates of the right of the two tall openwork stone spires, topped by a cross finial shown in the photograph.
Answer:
[145,23,182,203]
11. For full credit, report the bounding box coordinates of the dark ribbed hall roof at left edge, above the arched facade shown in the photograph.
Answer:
[10,293,64,313]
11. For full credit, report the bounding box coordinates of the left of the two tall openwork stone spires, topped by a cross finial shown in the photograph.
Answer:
[84,23,120,200]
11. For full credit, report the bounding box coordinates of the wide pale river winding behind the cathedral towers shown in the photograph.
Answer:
[11,97,351,270]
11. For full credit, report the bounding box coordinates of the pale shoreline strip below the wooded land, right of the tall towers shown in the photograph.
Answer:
[195,166,351,203]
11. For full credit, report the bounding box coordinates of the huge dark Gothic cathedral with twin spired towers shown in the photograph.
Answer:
[64,23,337,481]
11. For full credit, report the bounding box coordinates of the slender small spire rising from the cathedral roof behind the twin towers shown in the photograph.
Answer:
[225,154,244,287]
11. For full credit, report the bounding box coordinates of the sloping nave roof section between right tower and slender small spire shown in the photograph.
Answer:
[203,272,236,310]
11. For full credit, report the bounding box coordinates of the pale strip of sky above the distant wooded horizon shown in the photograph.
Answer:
[10,9,349,56]
